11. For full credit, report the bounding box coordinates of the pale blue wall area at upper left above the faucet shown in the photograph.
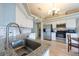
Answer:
[0,3,16,27]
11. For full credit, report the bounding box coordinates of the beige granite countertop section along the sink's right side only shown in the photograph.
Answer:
[27,40,50,56]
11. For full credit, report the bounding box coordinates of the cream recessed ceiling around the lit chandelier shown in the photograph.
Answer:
[26,3,79,18]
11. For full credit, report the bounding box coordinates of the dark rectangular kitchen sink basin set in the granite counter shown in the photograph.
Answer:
[14,39,41,56]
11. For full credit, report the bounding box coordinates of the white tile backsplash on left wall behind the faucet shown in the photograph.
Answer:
[0,27,32,38]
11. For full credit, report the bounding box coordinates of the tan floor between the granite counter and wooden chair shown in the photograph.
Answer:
[49,41,79,56]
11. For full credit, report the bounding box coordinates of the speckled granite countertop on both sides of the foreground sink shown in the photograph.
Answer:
[0,34,50,56]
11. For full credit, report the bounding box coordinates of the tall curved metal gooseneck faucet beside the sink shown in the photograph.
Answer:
[5,23,21,50]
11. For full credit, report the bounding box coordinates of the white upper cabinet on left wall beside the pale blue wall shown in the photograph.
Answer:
[16,6,33,28]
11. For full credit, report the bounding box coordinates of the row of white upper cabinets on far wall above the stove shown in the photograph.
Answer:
[44,18,76,29]
